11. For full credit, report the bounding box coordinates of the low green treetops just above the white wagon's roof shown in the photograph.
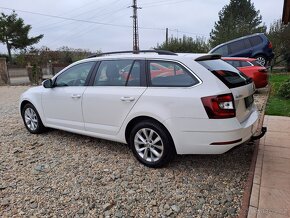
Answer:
[156,35,209,53]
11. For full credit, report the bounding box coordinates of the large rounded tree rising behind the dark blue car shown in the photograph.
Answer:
[210,0,266,47]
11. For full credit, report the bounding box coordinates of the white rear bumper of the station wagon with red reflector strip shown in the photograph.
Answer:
[165,111,258,154]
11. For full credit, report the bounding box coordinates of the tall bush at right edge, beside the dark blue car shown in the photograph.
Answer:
[267,19,290,71]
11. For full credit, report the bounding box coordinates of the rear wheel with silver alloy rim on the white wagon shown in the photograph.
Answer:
[129,120,176,168]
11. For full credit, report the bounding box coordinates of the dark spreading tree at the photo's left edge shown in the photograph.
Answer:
[0,12,43,60]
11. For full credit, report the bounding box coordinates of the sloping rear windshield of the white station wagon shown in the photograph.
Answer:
[198,59,252,88]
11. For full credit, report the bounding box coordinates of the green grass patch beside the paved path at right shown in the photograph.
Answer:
[266,74,290,117]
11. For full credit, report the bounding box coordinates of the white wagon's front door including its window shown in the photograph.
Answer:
[42,61,95,130]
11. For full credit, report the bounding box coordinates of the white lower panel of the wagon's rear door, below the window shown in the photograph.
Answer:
[82,86,147,135]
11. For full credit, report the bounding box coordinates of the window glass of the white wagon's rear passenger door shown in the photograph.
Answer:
[94,60,140,86]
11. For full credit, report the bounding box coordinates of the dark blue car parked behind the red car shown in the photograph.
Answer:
[209,33,274,66]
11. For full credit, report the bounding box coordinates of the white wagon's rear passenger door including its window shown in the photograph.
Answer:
[83,59,147,135]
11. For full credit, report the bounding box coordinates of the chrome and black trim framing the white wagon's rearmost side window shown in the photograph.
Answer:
[146,58,202,88]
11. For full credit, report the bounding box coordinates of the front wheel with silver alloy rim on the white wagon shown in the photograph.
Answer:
[21,103,46,134]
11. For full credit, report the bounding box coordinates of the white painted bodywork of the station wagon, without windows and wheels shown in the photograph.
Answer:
[20,54,258,154]
